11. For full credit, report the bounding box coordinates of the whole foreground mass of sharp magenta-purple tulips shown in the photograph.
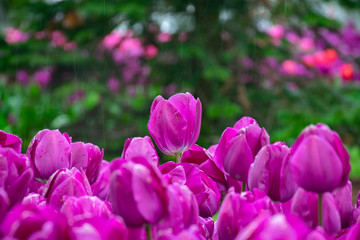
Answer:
[0,93,360,240]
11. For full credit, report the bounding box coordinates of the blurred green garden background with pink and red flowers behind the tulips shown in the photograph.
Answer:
[0,0,360,178]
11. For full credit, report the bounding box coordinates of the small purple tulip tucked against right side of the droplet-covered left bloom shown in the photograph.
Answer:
[70,142,104,184]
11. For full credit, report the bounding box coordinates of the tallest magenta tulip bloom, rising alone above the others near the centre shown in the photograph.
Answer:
[147,93,201,155]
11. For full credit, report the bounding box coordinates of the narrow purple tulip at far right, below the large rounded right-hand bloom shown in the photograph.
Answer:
[332,181,353,228]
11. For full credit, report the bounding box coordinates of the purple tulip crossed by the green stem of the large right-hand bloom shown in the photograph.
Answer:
[291,188,341,234]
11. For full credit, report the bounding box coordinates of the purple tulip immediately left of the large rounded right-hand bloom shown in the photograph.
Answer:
[248,142,297,202]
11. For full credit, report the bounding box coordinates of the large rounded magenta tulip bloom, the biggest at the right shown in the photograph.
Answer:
[290,123,351,193]
